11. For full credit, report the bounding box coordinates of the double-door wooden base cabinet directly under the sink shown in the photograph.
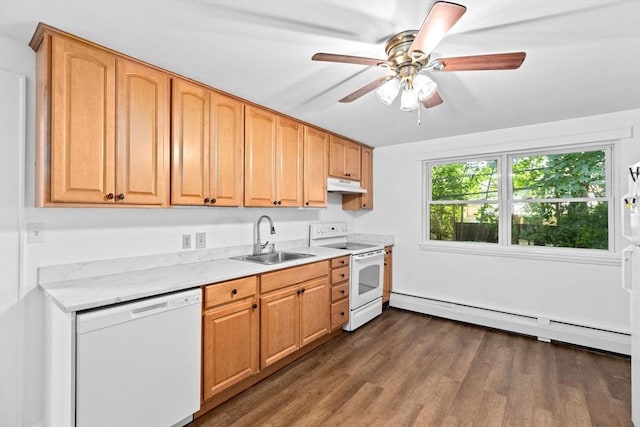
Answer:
[260,261,331,369]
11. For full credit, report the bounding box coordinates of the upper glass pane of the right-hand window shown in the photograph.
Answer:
[511,150,606,199]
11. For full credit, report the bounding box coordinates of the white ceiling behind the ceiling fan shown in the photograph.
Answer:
[0,0,640,146]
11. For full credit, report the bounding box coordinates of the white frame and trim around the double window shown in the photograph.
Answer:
[418,141,621,266]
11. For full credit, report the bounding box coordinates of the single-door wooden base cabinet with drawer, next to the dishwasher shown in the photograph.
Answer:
[202,276,260,401]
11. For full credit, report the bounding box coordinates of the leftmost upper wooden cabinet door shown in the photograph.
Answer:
[50,36,116,203]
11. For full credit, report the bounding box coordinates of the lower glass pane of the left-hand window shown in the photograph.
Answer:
[429,203,498,243]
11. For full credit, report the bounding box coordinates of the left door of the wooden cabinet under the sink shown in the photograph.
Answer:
[260,286,300,369]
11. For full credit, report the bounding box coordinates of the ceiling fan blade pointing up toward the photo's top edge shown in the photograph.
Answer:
[409,1,467,56]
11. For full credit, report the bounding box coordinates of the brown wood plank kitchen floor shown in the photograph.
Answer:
[193,309,632,427]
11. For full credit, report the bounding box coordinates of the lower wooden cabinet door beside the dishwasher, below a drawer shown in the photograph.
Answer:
[202,300,259,400]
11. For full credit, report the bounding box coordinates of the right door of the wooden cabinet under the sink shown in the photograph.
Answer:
[299,276,331,347]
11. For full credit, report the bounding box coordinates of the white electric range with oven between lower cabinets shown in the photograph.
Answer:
[309,222,384,331]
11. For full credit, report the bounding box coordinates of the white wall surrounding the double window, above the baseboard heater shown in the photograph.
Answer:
[356,110,640,338]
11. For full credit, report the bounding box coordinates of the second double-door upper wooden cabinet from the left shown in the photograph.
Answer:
[171,79,244,206]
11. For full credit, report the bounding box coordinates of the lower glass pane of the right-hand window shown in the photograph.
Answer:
[511,202,609,249]
